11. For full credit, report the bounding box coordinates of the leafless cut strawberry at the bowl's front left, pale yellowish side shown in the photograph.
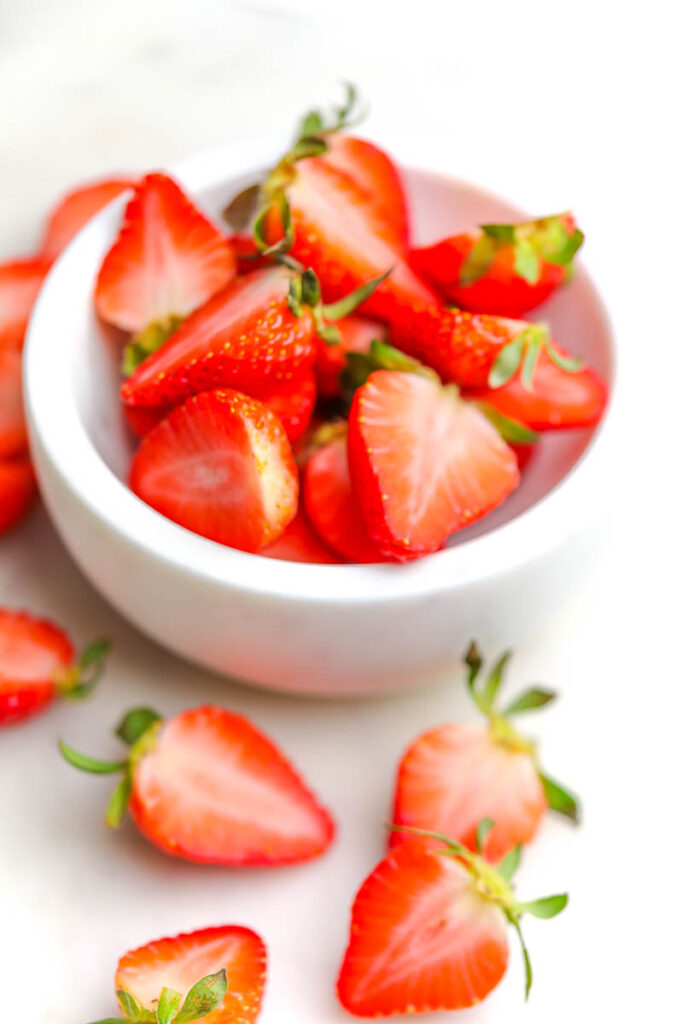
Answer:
[129,389,299,551]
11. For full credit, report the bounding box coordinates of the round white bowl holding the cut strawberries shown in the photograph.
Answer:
[25,140,614,694]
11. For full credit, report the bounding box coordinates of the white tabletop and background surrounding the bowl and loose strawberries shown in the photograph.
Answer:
[0,0,683,1024]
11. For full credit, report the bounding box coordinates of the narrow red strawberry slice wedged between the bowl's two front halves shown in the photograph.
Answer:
[303,435,384,562]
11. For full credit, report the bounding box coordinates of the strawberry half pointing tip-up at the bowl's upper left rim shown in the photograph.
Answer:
[95,174,236,332]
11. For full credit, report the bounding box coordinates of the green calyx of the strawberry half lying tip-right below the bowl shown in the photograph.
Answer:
[58,708,163,828]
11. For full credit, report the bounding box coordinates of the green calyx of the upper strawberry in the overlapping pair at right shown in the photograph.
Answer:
[464,642,580,823]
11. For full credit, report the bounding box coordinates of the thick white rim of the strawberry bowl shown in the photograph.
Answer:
[24,132,618,603]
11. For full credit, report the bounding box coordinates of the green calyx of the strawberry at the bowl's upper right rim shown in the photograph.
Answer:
[459,213,584,287]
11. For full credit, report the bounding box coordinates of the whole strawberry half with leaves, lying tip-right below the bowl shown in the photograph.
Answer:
[60,706,334,865]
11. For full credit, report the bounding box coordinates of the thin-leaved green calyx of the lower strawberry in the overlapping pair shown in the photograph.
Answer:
[392,818,569,998]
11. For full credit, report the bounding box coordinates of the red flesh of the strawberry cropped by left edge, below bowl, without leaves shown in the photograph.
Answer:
[0,608,74,726]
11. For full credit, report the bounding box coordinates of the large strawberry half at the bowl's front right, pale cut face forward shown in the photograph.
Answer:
[348,370,519,561]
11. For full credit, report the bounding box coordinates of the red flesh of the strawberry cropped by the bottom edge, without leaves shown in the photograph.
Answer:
[115,925,266,1024]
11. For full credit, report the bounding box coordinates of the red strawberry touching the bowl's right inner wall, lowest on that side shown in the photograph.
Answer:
[472,351,607,430]
